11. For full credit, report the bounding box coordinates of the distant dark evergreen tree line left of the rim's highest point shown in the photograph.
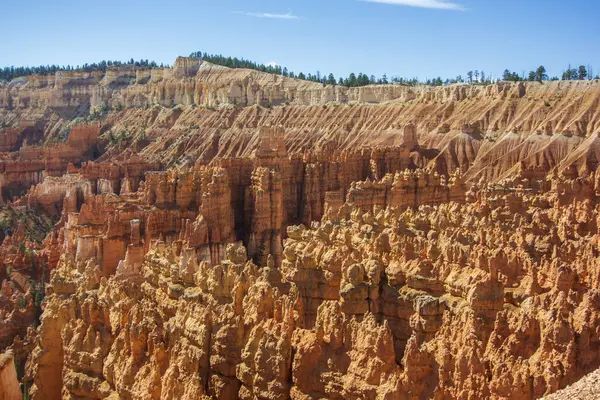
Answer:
[0,58,164,81]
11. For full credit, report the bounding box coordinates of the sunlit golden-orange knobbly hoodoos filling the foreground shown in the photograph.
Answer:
[22,169,600,399]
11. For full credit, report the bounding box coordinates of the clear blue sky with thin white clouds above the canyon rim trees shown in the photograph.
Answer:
[0,0,600,79]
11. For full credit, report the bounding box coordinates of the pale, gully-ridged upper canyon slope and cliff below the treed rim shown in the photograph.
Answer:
[0,58,600,182]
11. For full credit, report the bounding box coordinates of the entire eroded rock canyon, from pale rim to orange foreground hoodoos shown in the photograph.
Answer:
[0,58,600,400]
